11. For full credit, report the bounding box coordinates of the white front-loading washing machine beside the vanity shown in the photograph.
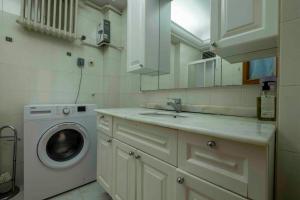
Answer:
[24,105,97,200]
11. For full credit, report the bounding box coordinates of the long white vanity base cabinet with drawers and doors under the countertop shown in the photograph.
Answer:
[97,116,274,200]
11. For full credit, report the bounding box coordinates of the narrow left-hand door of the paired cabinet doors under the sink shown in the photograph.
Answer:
[113,140,136,200]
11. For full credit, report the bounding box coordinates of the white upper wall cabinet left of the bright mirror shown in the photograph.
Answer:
[127,0,170,75]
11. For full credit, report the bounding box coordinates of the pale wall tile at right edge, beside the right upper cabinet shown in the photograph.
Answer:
[280,18,300,85]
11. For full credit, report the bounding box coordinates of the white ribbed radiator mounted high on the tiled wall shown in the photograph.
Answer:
[18,0,78,40]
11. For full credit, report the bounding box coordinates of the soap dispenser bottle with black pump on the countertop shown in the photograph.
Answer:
[257,81,276,121]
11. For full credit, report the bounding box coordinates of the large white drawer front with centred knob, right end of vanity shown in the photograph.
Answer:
[178,132,268,199]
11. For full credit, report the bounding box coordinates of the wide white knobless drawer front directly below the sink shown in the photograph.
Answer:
[113,118,178,166]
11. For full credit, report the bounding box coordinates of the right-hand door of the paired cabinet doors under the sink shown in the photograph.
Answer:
[136,151,176,200]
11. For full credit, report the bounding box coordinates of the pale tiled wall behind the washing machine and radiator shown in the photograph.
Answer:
[0,0,121,183]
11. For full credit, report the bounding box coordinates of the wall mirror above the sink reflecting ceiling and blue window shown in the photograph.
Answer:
[141,0,276,91]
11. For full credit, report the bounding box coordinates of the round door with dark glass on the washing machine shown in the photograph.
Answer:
[37,123,90,169]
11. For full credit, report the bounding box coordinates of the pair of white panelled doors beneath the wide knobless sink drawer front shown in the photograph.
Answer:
[113,140,176,200]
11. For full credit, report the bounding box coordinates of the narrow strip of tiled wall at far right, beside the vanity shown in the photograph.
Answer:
[276,0,300,200]
